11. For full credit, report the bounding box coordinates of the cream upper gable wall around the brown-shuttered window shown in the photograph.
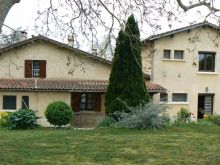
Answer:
[0,41,111,80]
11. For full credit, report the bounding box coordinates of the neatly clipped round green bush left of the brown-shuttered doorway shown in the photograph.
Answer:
[44,101,73,127]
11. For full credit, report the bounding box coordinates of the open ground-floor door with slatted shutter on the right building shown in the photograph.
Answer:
[197,94,214,119]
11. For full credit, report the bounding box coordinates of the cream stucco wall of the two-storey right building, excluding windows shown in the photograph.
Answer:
[146,27,220,114]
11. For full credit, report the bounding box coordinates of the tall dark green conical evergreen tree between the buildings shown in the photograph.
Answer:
[105,15,149,114]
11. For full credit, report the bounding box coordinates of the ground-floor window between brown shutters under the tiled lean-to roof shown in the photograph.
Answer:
[79,93,95,112]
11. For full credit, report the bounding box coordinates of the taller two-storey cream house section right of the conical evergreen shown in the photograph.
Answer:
[142,22,220,118]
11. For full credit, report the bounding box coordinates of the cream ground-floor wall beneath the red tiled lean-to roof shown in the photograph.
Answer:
[0,91,105,127]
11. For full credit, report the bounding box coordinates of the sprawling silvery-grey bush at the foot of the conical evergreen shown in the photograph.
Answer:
[118,102,168,129]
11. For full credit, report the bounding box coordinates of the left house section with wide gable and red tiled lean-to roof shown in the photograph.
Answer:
[0,36,166,127]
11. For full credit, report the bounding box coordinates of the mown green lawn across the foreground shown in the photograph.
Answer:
[0,126,220,165]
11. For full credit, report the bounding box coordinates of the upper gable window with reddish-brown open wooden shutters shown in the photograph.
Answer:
[25,60,46,78]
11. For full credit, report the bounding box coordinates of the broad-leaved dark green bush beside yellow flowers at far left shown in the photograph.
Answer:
[7,109,38,129]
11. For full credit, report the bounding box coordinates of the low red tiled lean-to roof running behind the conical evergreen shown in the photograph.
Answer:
[0,79,166,92]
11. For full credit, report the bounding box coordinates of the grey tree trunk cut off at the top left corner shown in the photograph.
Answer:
[0,0,20,33]
